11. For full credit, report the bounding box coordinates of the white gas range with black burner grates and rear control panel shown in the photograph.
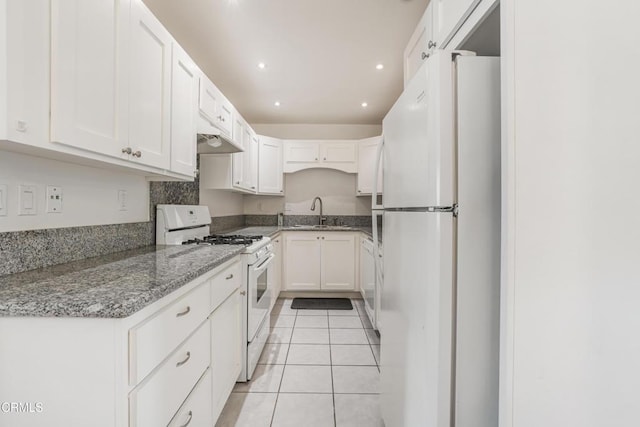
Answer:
[156,205,275,381]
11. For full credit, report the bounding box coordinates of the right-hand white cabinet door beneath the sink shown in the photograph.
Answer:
[320,233,357,291]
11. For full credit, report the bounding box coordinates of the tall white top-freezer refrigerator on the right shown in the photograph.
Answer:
[380,51,500,427]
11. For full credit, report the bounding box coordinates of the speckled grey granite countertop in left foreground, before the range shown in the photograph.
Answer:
[0,245,244,318]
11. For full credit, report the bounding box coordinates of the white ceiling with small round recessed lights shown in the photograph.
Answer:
[144,0,429,124]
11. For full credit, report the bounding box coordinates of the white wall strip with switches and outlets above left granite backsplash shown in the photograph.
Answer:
[0,151,149,232]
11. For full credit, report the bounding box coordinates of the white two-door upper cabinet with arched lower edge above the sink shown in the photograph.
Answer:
[283,140,358,173]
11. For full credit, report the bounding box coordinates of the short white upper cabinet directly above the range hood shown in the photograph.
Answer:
[199,75,234,142]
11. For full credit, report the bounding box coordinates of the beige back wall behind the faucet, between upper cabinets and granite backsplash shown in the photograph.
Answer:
[244,169,371,215]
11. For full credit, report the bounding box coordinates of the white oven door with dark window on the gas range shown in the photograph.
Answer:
[247,254,275,342]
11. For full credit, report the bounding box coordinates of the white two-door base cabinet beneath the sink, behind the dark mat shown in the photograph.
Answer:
[284,231,357,291]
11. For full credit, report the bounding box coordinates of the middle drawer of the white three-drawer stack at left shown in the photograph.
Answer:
[129,322,210,427]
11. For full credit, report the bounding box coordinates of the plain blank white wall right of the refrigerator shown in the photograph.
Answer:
[500,0,640,427]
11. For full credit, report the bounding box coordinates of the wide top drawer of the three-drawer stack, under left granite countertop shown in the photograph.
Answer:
[129,285,210,385]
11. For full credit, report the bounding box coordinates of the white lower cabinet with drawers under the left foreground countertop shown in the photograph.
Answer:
[0,257,243,427]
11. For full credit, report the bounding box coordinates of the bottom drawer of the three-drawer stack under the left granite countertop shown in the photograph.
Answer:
[169,369,213,427]
